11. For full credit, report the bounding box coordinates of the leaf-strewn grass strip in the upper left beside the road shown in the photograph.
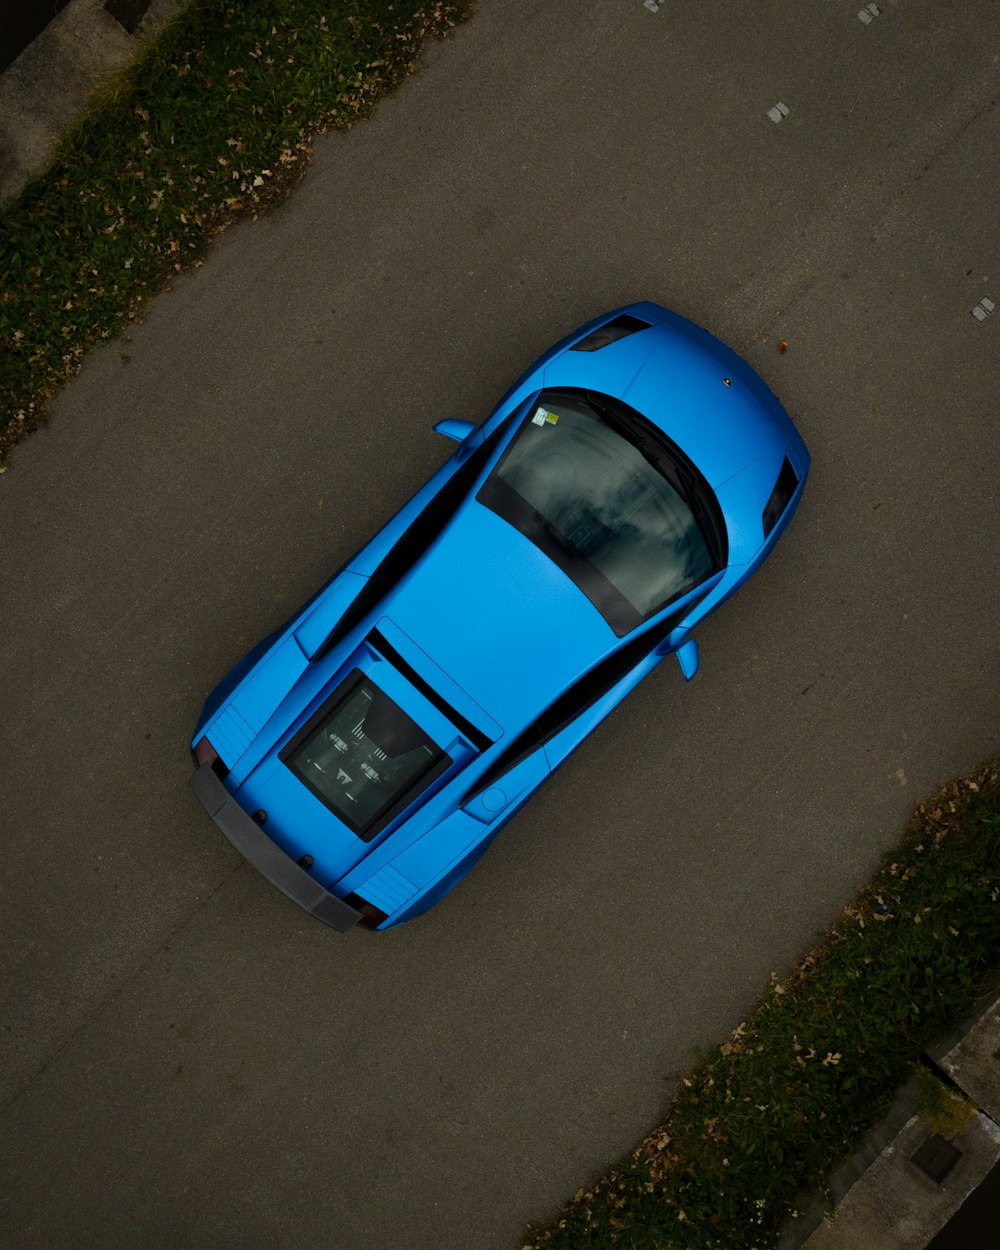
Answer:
[0,0,469,470]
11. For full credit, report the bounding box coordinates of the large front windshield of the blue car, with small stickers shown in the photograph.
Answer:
[476,393,719,635]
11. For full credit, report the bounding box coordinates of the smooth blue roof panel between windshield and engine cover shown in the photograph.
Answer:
[383,500,616,734]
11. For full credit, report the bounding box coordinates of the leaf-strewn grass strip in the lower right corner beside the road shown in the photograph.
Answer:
[525,760,1000,1250]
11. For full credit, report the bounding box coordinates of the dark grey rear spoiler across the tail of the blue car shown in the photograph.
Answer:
[191,764,361,933]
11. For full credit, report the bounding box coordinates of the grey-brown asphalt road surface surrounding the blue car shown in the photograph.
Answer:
[0,0,1000,1250]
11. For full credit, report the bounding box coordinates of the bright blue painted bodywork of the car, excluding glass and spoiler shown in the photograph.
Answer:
[193,303,809,928]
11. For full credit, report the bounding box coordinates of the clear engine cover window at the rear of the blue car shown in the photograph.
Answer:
[279,669,451,839]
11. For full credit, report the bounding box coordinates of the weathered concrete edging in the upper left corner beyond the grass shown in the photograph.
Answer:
[0,0,193,203]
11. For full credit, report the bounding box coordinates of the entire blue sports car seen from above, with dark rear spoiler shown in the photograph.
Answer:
[191,303,809,930]
